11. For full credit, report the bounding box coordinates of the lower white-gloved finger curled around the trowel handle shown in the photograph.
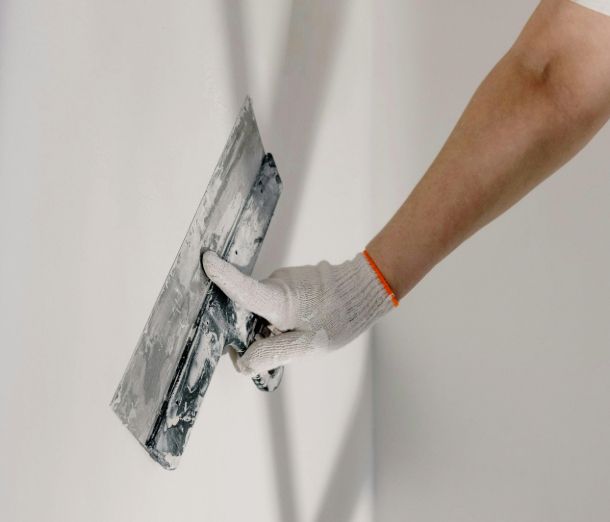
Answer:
[234,331,315,377]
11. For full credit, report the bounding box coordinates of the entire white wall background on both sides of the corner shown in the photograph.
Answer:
[0,0,610,522]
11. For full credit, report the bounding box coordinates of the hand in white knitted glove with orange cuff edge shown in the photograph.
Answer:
[202,251,398,376]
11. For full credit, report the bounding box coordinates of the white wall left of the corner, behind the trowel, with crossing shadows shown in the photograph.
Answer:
[0,0,372,522]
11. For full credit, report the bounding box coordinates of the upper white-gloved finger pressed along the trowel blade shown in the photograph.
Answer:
[201,250,293,324]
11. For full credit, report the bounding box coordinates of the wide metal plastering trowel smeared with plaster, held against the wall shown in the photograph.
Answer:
[111,98,283,469]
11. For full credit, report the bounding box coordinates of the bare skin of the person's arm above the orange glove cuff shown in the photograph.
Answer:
[367,0,610,298]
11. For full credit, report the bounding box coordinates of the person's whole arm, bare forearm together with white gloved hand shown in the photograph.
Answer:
[203,0,610,375]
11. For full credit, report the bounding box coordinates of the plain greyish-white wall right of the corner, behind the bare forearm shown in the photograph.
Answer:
[372,0,610,522]
